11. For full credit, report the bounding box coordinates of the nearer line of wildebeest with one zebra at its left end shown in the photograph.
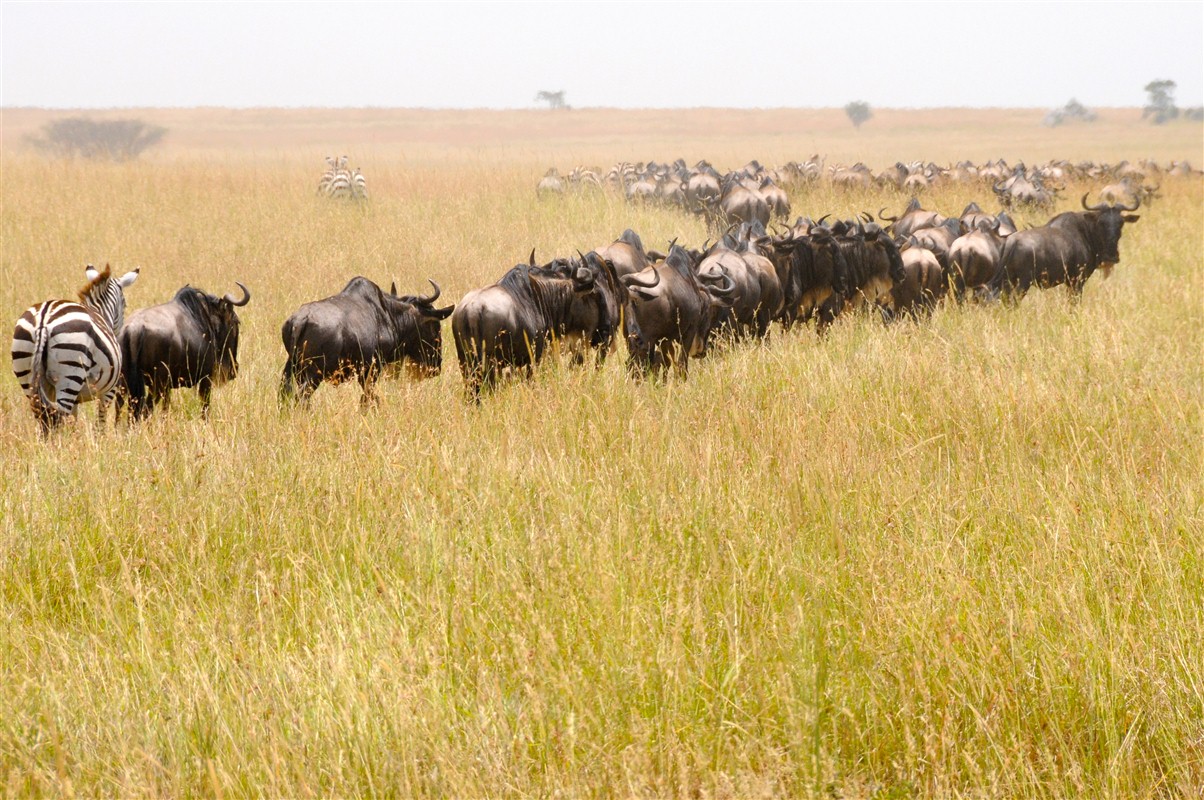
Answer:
[12,186,1140,435]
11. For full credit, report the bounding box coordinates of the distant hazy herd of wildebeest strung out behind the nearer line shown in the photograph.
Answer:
[536,154,1196,229]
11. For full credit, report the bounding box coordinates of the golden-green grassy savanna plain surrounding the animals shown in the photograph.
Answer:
[0,110,1204,798]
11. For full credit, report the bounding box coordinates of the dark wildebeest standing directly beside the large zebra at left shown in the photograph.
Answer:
[118,282,250,419]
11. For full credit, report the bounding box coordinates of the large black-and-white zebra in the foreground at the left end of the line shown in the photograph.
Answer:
[12,264,138,434]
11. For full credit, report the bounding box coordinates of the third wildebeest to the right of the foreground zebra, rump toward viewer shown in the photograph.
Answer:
[452,251,598,400]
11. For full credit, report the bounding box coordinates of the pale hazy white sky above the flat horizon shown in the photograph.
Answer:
[0,0,1204,108]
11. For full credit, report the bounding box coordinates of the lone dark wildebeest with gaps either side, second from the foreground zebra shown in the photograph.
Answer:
[281,276,455,405]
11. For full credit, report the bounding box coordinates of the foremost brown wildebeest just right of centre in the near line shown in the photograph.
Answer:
[622,243,733,377]
